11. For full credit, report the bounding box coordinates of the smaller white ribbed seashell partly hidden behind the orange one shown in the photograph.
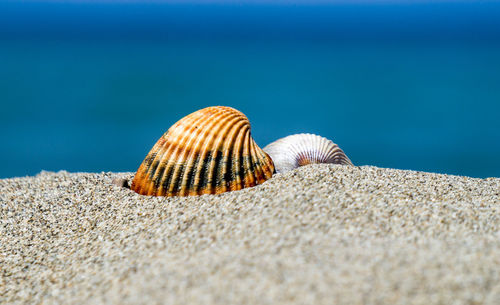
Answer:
[264,133,353,173]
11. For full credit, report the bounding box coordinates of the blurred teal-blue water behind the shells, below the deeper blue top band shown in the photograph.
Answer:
[0,2,500,178]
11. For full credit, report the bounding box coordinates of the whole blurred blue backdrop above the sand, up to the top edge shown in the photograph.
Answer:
[0,0,500,178]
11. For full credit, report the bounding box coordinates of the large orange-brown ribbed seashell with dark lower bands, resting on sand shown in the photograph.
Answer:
[131,106,274,196]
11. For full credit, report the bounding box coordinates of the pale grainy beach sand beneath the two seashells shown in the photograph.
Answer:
[0,165,500,305]
